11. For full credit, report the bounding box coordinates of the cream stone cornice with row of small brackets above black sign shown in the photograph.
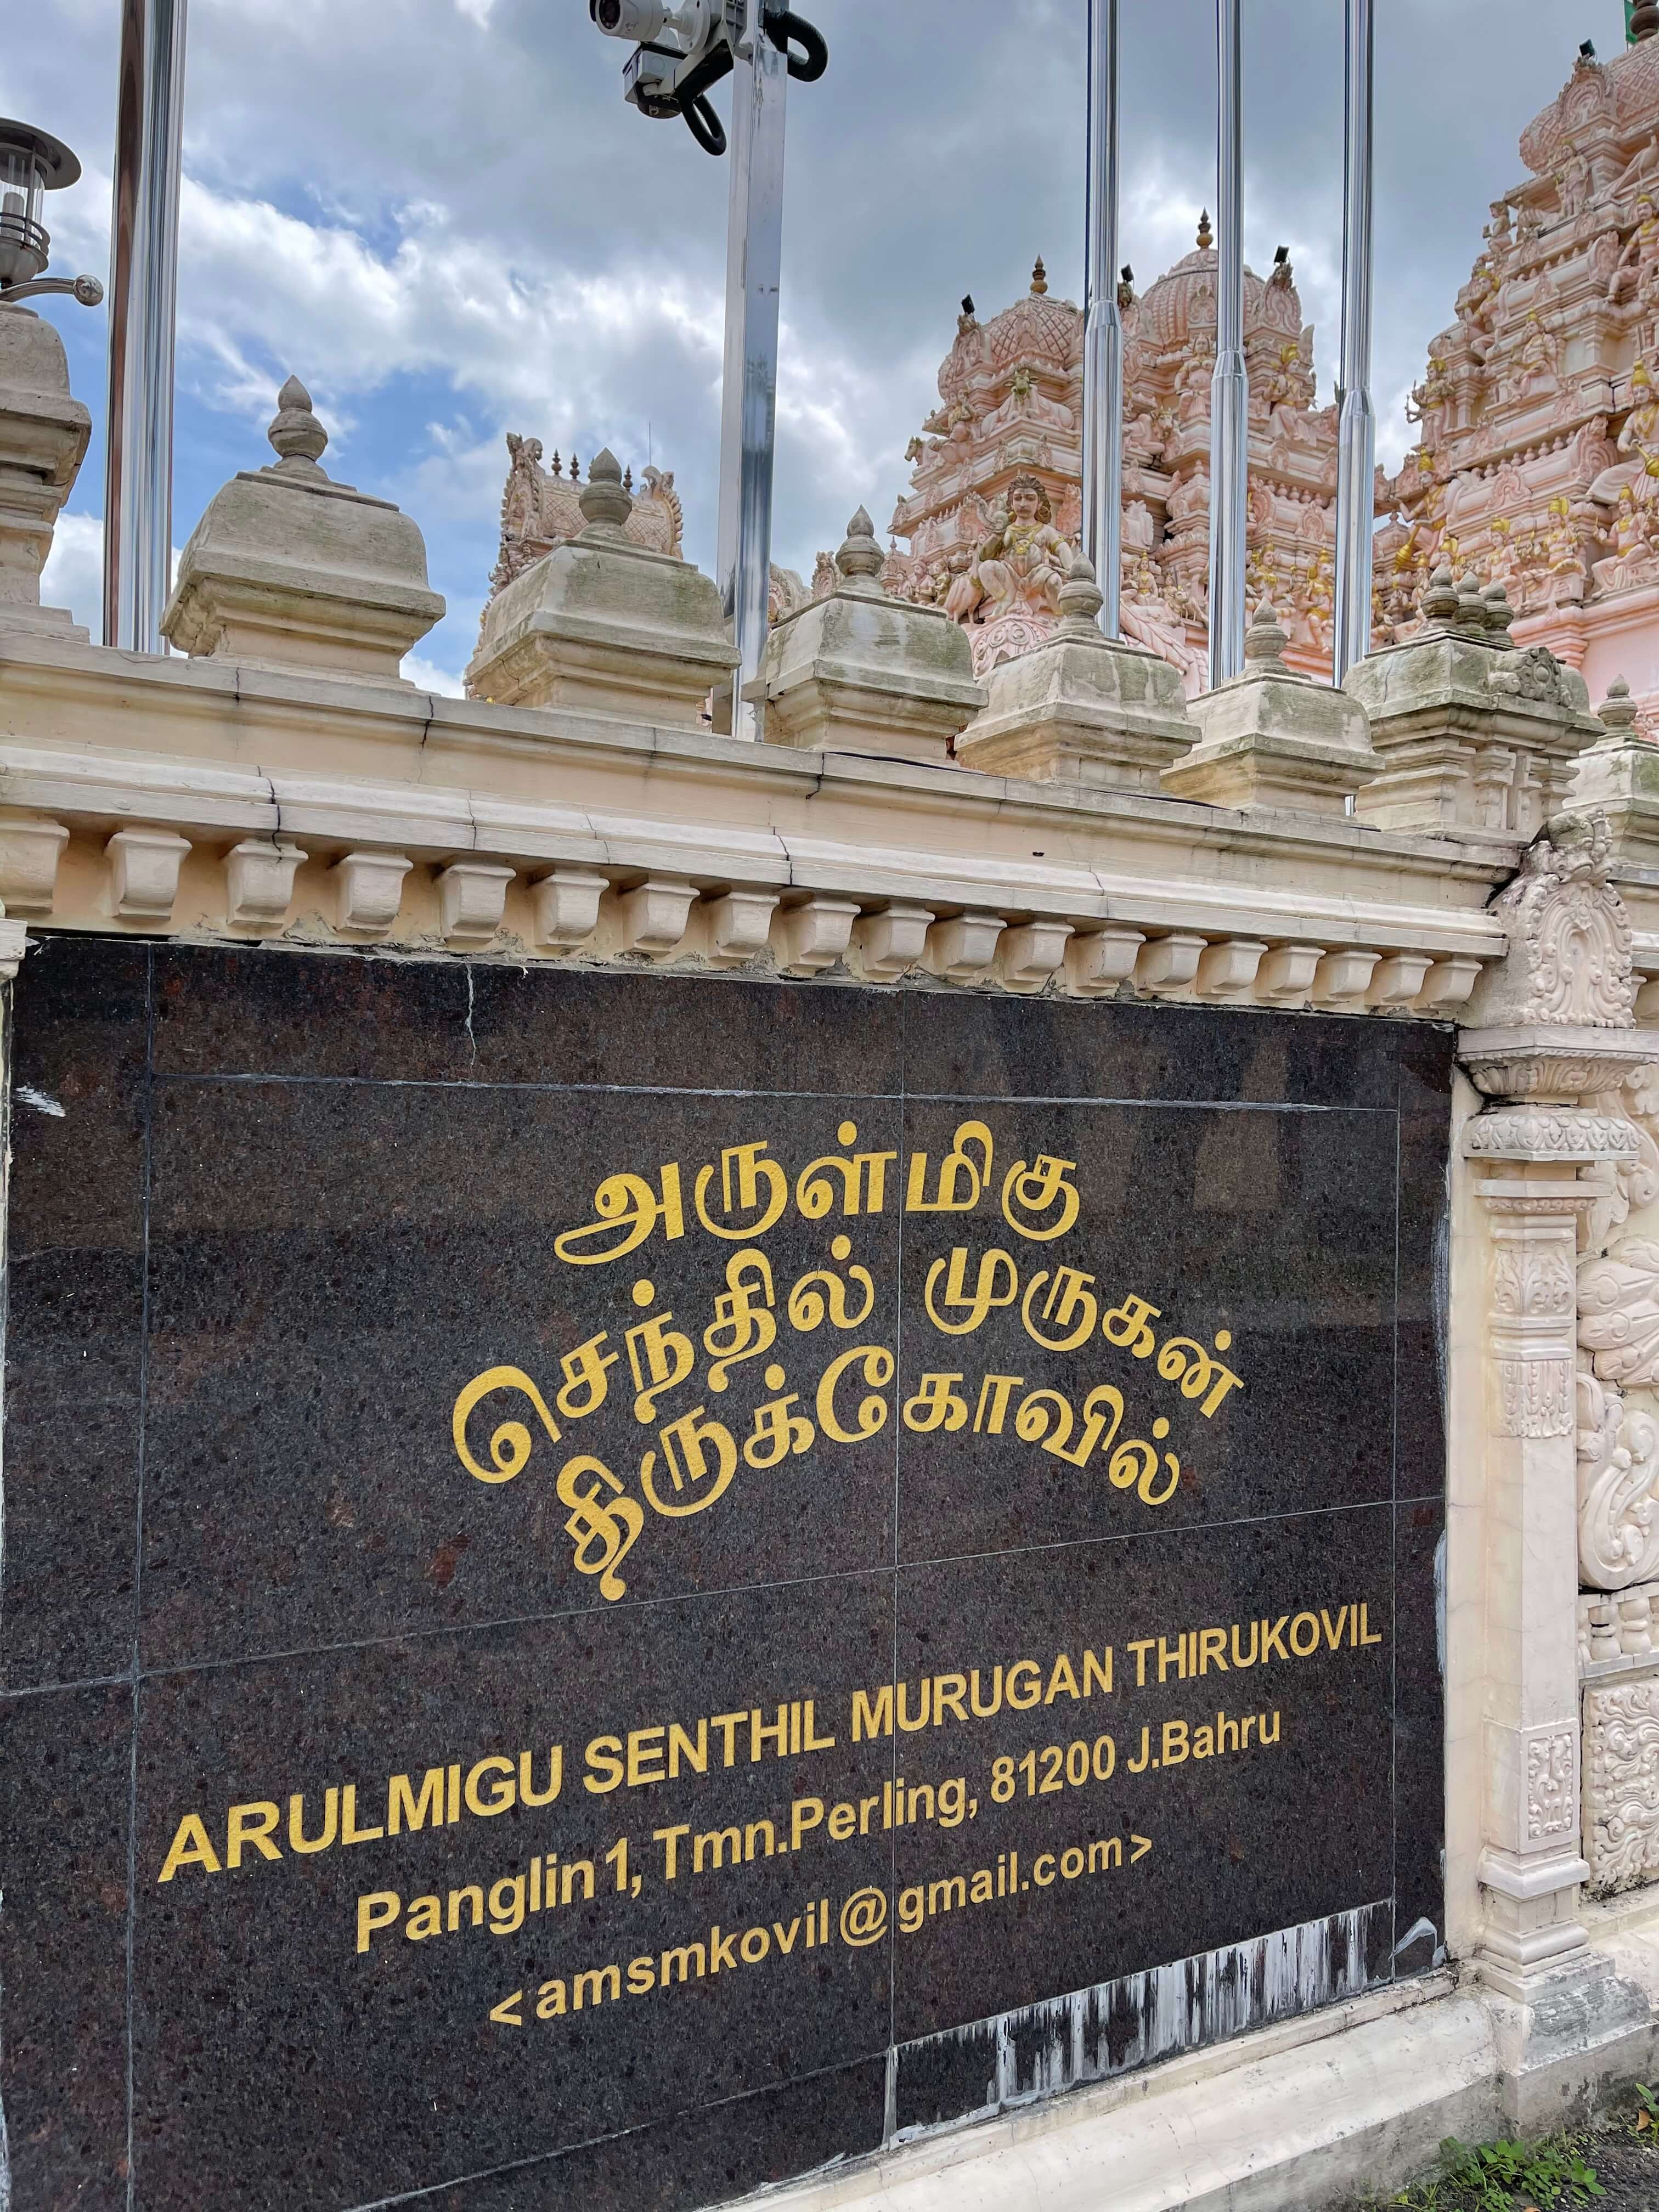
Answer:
[0,639,1520,1018]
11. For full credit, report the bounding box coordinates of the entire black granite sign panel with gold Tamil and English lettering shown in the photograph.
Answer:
[0,938,1451,2212]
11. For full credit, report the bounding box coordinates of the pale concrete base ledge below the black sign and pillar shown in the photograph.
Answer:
[765,1903,1659,2212]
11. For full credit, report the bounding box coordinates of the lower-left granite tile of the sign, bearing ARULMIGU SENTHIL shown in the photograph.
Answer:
[133,1575,891,2205]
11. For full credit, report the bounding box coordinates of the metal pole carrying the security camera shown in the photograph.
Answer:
[714,0,789,739]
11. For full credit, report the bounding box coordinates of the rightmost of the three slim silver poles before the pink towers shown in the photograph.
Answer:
[1331,0,1376,684]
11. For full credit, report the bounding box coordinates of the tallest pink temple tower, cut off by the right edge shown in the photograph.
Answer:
[1376,24,1659,735]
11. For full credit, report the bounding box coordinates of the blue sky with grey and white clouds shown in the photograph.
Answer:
[0,0,1623,688]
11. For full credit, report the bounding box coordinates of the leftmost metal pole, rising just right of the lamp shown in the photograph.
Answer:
[104,0,186,652]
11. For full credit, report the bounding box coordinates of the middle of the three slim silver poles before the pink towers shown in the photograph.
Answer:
[1210,0,1250,686]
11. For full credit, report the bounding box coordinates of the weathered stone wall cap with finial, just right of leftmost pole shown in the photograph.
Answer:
[161,376,444,684]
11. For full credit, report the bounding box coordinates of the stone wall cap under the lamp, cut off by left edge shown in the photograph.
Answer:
[0,307,93,646]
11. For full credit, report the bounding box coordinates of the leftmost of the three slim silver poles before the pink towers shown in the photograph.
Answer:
[1084,0,1124,637]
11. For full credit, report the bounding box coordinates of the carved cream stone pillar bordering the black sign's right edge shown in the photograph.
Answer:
[1460,816,1659,2124]
